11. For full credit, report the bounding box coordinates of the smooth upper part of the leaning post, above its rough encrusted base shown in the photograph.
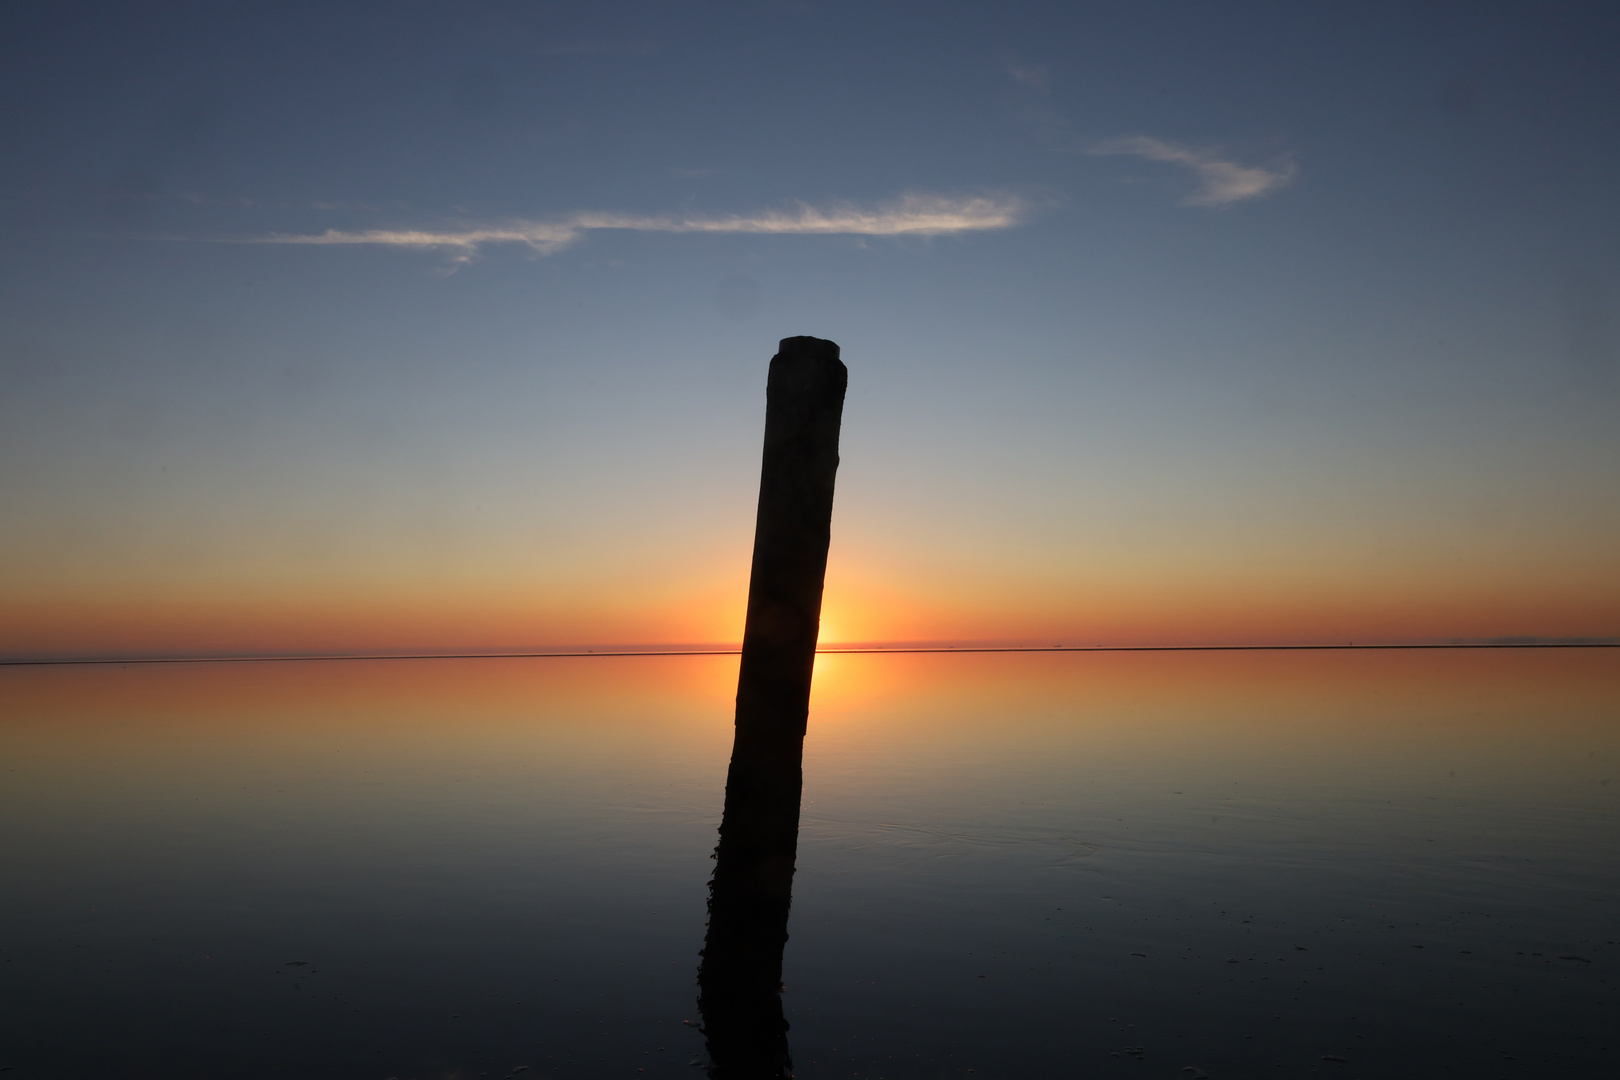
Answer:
[737,337,849,737]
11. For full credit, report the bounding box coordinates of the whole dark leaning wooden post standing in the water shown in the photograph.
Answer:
[698,337,847,1080]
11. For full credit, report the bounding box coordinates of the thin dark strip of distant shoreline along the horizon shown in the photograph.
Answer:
[0,641,1620,667]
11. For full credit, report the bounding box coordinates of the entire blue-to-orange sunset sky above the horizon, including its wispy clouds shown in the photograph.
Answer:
[0,0,1620,659]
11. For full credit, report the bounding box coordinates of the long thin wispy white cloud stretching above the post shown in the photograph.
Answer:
[217,194,1029,262]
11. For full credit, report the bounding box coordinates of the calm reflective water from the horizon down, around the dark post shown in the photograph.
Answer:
[0,649,1620,1080]
